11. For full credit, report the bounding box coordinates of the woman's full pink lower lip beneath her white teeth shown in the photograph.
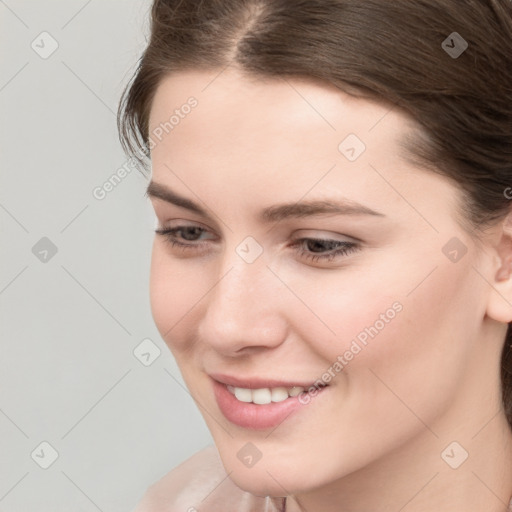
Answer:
[213,380,328,430]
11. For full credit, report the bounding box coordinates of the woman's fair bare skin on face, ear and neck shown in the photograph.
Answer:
[146,68,512,512]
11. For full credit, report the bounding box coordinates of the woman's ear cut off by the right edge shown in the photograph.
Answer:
[487,210,512,323]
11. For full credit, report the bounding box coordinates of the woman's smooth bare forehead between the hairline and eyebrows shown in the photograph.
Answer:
[150,69,456,233]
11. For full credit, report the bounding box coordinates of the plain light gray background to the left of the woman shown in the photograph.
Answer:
[0,0,212,512]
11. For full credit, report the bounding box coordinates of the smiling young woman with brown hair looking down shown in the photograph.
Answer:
[119,0,512,512]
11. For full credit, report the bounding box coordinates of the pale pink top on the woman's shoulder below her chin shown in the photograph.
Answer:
[132,445,512,512]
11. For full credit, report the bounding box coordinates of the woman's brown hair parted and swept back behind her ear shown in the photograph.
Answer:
[118,0,512,427]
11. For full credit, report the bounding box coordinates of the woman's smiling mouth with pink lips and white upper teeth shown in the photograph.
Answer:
[210,375,329,429]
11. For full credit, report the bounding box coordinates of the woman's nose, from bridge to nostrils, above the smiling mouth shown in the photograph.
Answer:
[198,250,287,357]
